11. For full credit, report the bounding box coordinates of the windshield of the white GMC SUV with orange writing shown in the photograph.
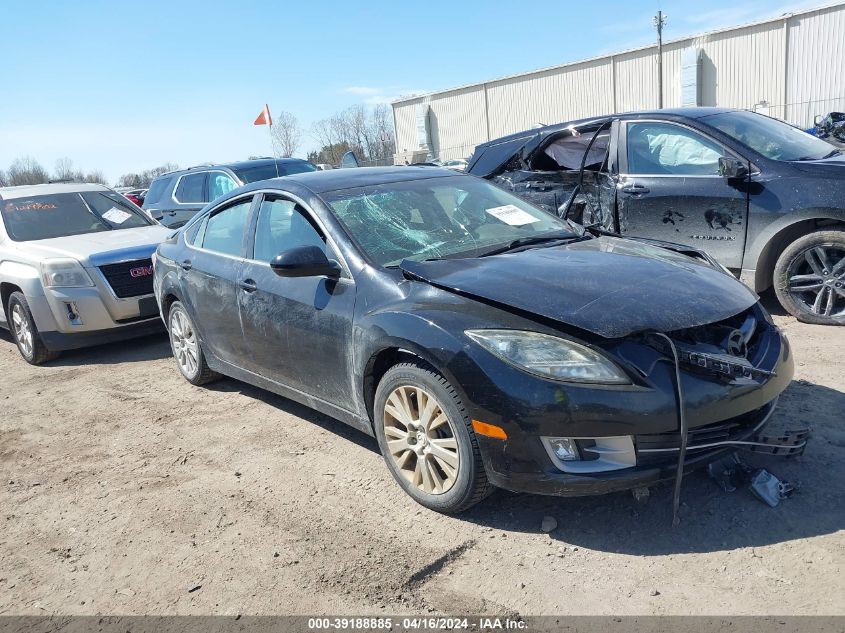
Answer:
[0,191,155,242]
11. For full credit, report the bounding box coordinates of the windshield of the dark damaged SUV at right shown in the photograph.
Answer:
[702,112,839,160]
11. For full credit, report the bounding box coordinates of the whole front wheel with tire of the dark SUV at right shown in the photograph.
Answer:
[774,230,845,325]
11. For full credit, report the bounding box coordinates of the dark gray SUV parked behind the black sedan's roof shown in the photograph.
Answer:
[143,158,317,229]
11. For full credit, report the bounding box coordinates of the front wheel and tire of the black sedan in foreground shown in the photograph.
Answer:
[374,363,493,514]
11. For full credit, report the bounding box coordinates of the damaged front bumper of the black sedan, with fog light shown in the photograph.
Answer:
[458,308,806,496]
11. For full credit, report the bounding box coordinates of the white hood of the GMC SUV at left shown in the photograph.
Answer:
[17,226,173,266]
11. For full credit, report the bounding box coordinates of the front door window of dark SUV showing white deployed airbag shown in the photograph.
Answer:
[627,122,724,176]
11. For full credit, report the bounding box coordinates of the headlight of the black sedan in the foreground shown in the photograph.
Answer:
[466,330,631,385]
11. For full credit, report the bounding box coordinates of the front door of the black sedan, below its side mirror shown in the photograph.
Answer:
[239,195,355,410]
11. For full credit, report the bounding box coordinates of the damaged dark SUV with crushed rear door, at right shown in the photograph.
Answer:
[466,108,845,325]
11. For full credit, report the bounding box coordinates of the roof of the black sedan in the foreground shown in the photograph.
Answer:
[266,166,461,194]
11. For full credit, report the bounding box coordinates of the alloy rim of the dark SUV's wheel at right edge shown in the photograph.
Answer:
[788,245,845,317]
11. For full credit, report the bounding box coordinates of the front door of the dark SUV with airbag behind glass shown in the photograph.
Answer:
[617,120,748,268]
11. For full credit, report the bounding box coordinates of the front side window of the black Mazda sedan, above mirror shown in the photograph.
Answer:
[253,199,327,262]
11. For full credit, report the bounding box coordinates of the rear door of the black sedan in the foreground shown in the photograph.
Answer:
[177,195,254,366]
